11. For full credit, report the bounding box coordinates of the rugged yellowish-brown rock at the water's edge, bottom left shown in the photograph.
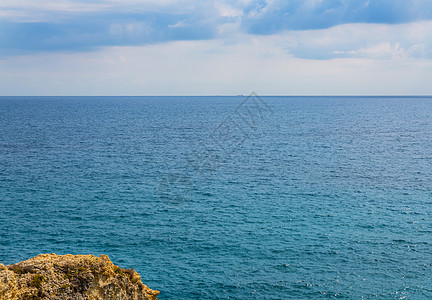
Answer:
[0,254,159,300]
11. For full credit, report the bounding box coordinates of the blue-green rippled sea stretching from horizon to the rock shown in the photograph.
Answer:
[0,97,432,299]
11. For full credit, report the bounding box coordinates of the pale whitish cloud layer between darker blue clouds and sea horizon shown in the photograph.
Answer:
[0,9,432,95]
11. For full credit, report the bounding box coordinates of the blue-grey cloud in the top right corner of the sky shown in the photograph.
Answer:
[242,0,432,34]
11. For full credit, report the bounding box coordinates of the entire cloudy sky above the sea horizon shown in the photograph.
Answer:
[0,0,432,96]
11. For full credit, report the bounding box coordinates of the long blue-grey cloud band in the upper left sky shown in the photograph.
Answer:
[0,13,215,54]
